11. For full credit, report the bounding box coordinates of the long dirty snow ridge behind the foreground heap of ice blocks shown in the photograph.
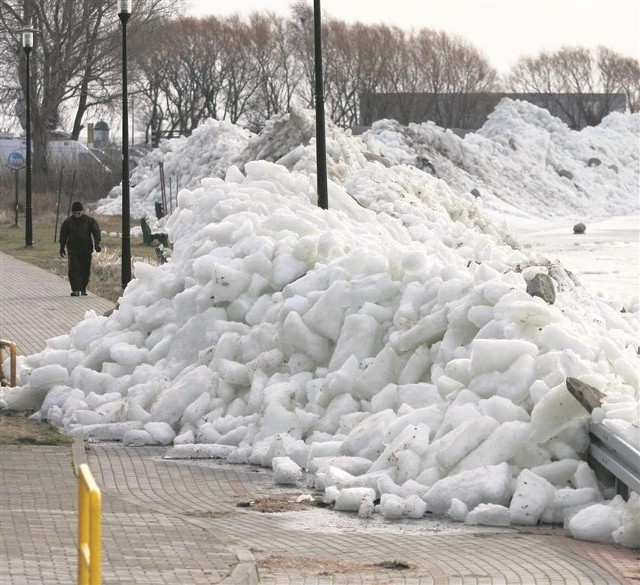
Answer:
[98,99,640,223]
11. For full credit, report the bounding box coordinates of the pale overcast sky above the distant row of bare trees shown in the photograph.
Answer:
[189,0,640,73]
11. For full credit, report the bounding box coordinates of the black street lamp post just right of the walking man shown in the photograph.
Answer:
[118,0,131,289]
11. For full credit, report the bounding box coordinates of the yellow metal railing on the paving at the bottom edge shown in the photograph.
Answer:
[78,463,102,585]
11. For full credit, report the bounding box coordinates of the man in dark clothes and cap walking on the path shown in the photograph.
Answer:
[60,201,102,297]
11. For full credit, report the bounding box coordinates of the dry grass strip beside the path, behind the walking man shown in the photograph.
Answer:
[0,193,158,303]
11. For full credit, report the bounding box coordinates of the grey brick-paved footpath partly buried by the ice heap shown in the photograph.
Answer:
[0,252,640,585]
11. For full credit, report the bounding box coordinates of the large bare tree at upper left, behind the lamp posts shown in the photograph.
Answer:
[0,0,182,173]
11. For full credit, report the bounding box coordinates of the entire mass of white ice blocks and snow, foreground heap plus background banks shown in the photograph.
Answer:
[0,101,640,546]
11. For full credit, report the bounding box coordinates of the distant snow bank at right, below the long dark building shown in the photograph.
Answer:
[363,99,640,219]
